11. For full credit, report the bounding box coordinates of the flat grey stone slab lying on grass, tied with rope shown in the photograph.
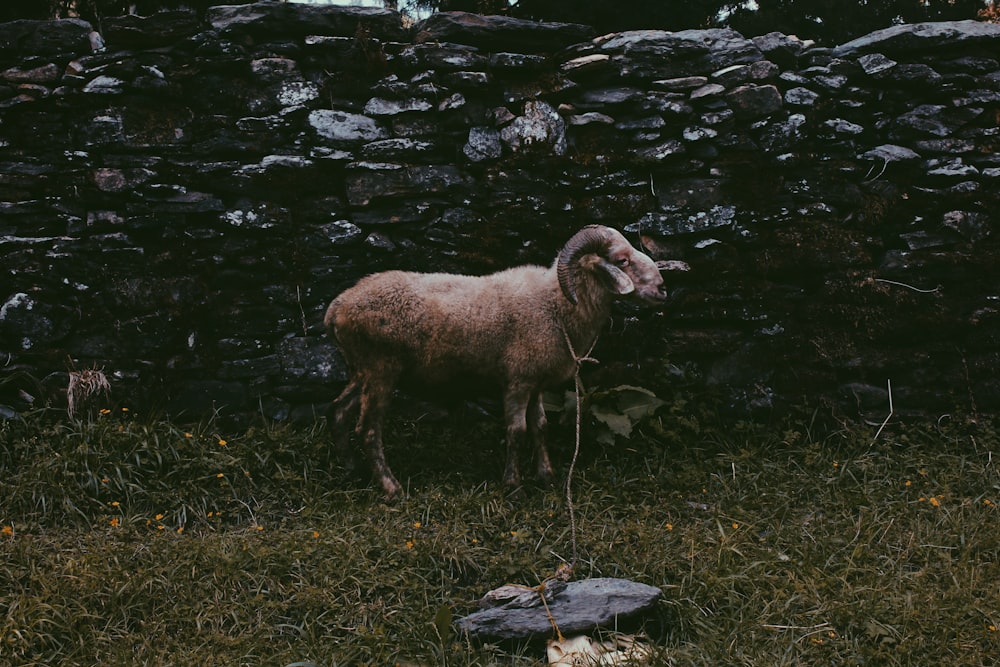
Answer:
[455,578,662,639]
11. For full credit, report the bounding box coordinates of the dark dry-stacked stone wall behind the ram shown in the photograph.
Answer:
[0,2,1000,418]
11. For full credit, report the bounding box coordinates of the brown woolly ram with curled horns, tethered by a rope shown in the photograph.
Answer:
[324,225,667,497]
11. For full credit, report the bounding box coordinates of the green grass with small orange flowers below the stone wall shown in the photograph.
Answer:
[0,410,1000,666]
